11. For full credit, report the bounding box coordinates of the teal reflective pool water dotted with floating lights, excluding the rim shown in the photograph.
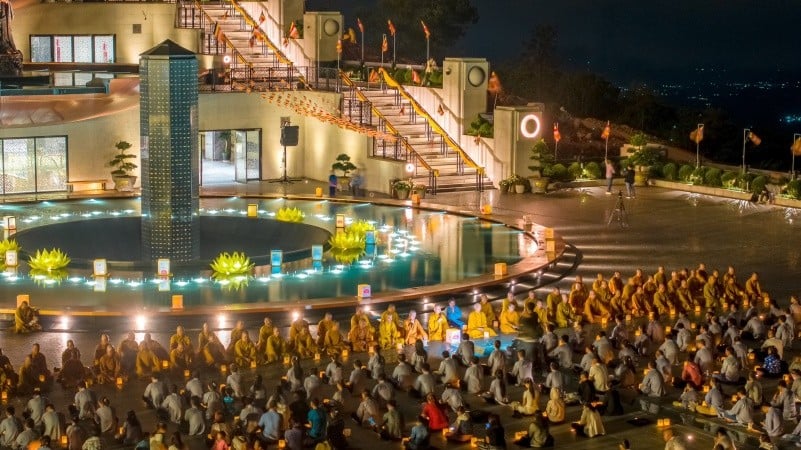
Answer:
[0,197,537,315]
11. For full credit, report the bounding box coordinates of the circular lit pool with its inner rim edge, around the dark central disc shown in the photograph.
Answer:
[0,197,552,315]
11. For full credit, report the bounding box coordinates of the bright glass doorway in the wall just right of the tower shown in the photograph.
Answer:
[198,129,261,186]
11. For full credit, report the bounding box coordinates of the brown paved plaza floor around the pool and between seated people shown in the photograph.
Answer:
[0,182,801,449]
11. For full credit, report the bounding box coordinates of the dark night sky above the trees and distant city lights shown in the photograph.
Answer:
[322,0,801,84]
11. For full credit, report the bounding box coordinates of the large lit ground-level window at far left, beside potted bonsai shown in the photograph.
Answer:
[0,136,67,194]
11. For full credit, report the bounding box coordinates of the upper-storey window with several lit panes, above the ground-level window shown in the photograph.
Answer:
[31,34,116,64]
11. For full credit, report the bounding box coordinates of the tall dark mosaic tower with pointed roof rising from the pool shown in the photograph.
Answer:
[139,40,200,262]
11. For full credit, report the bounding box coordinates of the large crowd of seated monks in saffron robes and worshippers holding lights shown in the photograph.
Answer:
[0,265,801,450]
